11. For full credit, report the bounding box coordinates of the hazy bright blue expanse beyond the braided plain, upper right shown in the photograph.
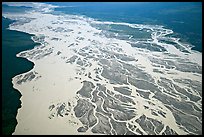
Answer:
[50,2,202,52]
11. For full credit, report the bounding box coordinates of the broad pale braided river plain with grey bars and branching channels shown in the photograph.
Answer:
[2,3,202,135]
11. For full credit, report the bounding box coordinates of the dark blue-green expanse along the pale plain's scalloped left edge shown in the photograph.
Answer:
[2,17,37,135]
